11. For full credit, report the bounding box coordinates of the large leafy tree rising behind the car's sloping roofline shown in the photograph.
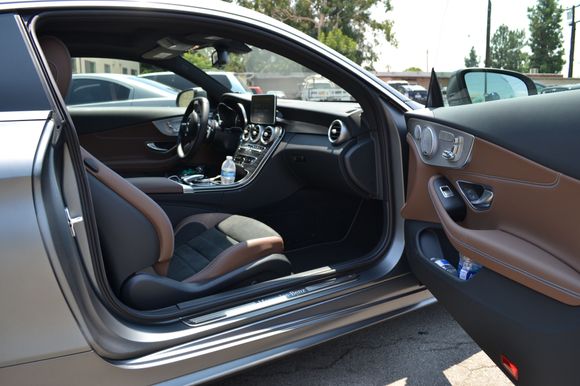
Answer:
[229,0,397,67]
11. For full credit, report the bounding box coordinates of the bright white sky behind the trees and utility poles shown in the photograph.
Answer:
[373,0,580,77]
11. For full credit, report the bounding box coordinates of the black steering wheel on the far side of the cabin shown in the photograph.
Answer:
[177,97,209,158]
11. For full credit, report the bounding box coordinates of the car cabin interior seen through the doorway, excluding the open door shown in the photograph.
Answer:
[36,12,388,310]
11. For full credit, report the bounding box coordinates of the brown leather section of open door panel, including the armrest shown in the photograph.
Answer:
[402,134,580,305]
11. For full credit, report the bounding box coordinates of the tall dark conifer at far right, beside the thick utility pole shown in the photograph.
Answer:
[528,0,564,73]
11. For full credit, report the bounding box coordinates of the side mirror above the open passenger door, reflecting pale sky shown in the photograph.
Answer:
[447,68,538,106]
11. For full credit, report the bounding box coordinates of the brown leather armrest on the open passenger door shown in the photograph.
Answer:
[428,175,580,306]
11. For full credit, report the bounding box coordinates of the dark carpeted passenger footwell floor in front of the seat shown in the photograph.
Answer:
[248,189,384,273]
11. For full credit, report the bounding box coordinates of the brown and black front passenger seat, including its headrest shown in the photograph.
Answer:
[39,37,292,309]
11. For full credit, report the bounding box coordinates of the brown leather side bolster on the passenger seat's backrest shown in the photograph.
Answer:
[81,148,174,262]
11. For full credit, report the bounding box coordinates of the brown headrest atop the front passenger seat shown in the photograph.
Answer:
[39,36,72,98]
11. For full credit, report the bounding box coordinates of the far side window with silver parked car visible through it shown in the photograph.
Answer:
[66,58,185,108]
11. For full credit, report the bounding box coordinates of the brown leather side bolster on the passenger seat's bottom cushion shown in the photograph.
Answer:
[184,236,284,283]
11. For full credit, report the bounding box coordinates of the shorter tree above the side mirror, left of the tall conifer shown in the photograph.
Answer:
[491,24,528,72]
